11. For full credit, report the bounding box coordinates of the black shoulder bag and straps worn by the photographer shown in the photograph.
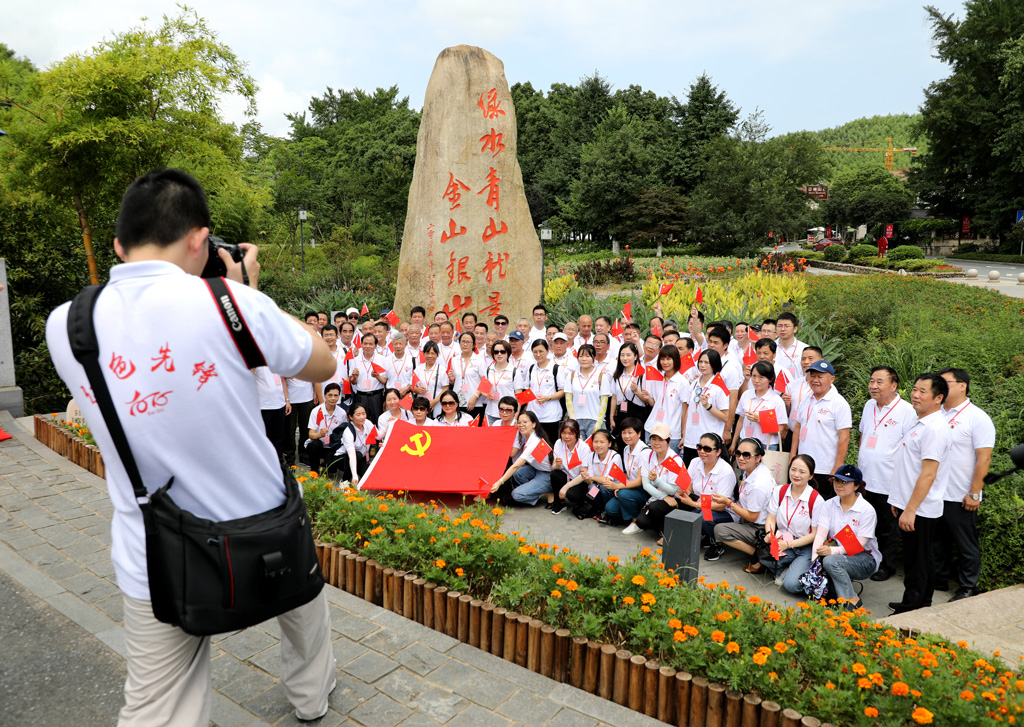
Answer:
[68,277,324,636]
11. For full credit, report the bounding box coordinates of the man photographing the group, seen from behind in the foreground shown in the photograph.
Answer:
[46,169,335,725]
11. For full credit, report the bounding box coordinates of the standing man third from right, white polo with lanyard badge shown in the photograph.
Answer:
[856,366,918,581]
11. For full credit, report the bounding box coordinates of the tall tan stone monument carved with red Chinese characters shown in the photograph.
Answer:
[395,45,544,324]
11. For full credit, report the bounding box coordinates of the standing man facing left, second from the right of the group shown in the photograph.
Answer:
[889,374,950,613]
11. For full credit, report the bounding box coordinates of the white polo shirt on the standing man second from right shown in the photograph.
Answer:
[889,412,950,517]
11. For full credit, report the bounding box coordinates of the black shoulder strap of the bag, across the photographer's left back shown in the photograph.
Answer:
[68,286,150,506]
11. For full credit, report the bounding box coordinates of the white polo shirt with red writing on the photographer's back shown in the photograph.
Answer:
[46,260,312,600]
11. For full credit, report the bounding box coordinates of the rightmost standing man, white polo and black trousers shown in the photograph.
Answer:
[935,369,995,601]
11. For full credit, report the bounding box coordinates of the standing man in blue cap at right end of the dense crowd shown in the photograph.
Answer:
[790,360,853,500]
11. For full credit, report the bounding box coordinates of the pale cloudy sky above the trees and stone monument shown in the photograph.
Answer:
[6,0,963,136]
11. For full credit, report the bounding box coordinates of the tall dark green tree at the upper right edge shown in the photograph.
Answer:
[910,0,1024,243]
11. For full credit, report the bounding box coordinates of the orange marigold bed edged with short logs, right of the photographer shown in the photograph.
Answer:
[302,475,1024,726]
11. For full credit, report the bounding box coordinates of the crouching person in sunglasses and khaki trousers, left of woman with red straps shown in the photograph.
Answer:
[712,437,775,573]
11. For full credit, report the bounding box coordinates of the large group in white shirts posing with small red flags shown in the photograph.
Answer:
[257,305,995,612]
